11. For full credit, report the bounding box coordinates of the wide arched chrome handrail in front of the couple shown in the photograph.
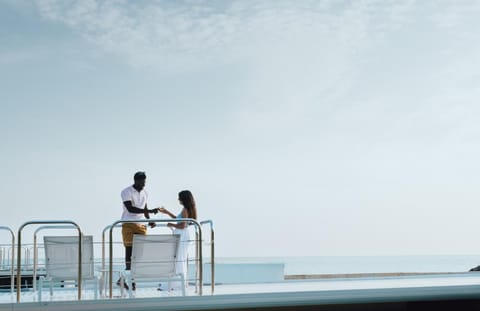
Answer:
[108,218,203,299]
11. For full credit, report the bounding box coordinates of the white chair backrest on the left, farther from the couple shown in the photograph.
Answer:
[43,235,94,280]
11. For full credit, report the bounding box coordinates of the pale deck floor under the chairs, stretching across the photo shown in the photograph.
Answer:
[0,273,480,305]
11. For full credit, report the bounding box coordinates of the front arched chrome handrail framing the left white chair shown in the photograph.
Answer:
[17,220,83,303]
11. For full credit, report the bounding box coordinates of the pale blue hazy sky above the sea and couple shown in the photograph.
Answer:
[0,0,480,257]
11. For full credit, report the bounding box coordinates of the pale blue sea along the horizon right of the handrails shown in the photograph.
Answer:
[216,255,480,275]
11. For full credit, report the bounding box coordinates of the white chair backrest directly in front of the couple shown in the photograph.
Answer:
[130,234,180,278]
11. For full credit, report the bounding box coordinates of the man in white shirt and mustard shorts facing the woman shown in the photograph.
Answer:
[117,172,158,285]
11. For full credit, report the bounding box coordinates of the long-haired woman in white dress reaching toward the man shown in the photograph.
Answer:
[159,190,197,292]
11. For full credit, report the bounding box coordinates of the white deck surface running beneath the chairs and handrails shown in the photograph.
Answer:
[0,273,480,310]
